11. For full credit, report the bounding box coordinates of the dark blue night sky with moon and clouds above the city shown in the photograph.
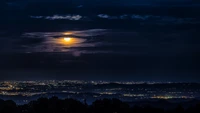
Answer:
[0,0,200,82]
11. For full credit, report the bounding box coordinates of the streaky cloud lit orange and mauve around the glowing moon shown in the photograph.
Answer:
[18,29,107,52]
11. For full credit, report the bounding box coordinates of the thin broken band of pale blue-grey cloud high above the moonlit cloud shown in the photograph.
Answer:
[30,14,200,24]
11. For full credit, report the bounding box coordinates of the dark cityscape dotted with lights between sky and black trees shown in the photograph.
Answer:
[0,80,200,104]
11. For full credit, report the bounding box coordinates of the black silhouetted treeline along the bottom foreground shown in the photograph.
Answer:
[0,97,200,113]
